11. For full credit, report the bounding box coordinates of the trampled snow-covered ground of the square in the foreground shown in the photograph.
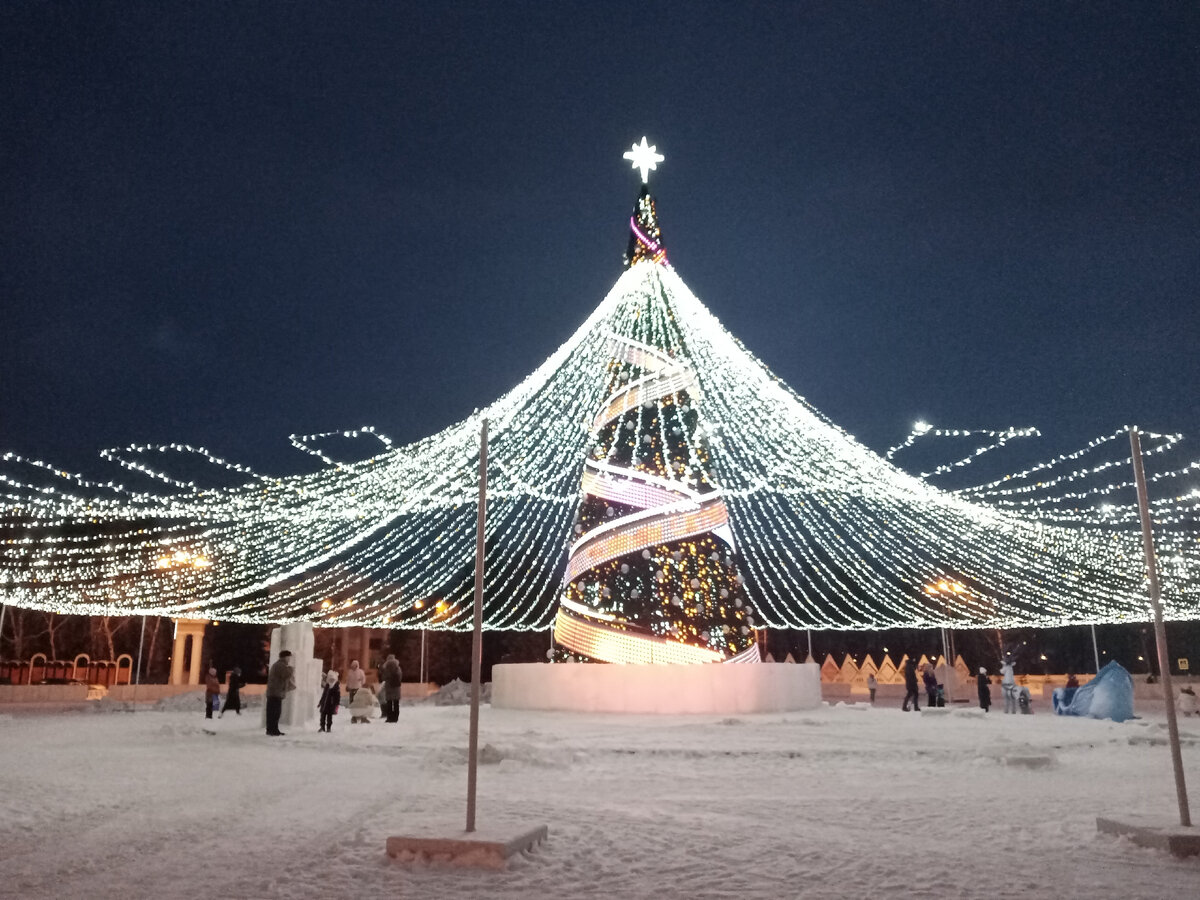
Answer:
[0,697,1200,900]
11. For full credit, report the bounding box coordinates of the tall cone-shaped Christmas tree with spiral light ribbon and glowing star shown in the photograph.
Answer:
[554,138,758,662]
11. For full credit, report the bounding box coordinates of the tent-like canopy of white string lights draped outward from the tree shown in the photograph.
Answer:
[0,142,1200,633]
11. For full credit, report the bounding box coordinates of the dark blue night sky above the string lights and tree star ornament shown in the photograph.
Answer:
[0,2,1200,482]
